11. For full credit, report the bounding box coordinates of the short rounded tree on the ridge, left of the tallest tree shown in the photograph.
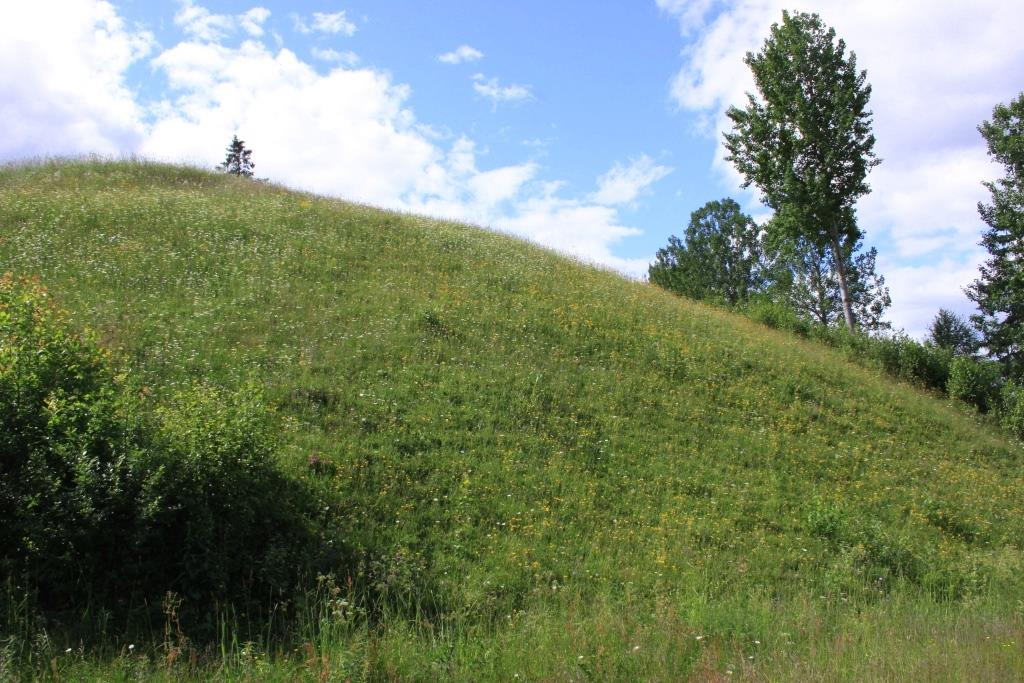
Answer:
[648,199,763,305]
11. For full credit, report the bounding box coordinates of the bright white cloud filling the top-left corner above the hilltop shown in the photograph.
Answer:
[0,0,154,160]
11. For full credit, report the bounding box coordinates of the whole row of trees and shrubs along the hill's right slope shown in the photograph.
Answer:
[648,11,1024,432]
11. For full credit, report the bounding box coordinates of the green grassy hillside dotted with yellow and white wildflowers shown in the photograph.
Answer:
[0,162,1024,680]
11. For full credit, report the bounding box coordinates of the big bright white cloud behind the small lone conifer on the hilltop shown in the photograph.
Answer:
[142,42,438,205]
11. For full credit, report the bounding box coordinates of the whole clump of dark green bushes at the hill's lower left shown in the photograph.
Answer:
[0,274,311,609]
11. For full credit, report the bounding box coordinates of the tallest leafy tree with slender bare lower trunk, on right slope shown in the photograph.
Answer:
[725,11,880,330]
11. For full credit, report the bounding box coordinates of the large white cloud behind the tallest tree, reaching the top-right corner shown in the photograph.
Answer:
[656,0,1024,330]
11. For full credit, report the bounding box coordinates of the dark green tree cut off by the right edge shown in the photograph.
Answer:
[967,92,1024,379]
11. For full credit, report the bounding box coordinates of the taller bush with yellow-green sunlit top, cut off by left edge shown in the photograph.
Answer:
[0,273,131,603]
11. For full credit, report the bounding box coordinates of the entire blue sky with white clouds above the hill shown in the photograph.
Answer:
[0,0,1024,336]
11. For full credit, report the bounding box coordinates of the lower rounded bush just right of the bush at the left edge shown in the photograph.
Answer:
[134,385,312,602]
